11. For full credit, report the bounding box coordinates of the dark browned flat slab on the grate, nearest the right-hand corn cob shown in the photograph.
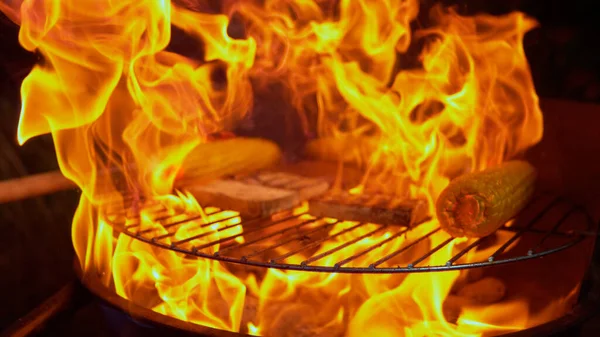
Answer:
[308,192,428,226]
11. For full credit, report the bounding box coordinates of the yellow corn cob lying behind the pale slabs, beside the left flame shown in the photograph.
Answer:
[178,138,281,182]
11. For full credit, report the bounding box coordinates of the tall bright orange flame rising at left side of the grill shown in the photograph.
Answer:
[18,0,256,201]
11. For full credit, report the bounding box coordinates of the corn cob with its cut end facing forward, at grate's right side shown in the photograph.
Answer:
[436,160,536,237]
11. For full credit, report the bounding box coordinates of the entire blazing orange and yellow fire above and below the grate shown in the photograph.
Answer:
[0,0,542,336]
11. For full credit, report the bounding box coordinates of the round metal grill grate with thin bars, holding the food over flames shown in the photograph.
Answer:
[105,194,596,273]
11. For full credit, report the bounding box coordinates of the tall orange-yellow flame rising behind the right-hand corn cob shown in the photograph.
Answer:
[231,0,542,205]
